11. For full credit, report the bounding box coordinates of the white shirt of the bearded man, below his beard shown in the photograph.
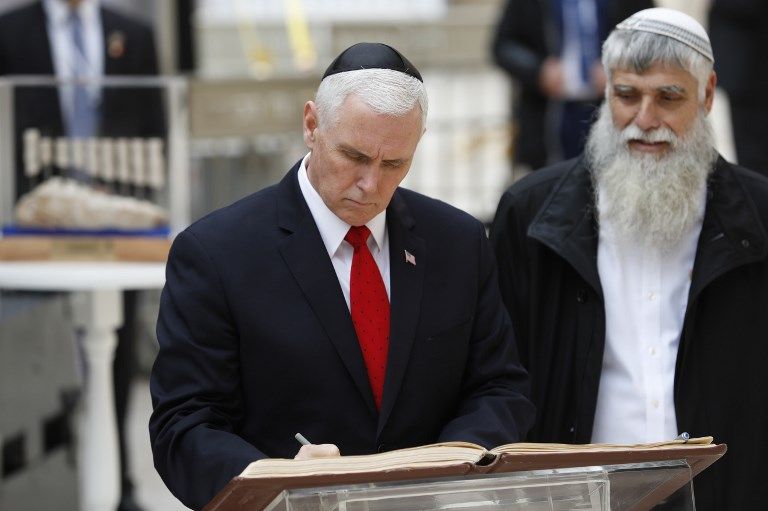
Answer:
[592,190,706,443]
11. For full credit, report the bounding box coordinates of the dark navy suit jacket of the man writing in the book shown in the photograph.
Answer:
[150,164,534,508]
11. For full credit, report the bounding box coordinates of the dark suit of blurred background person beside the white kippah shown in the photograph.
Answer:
[493,0,654,170]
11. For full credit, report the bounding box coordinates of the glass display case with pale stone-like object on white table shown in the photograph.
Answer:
[0,76,189,259]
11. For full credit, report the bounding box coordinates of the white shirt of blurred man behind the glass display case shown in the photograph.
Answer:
[43,0,104,125]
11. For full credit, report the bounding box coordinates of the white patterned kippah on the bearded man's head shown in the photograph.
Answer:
[616,7,715,62]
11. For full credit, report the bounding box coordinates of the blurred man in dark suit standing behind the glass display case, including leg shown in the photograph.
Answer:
[0,0,164,510]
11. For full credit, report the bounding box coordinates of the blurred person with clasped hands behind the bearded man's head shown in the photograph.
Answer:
[493,0,653,175]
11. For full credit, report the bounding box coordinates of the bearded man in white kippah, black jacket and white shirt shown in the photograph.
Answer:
[491,9,768,510]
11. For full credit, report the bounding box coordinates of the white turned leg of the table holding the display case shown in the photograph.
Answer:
[72,290,123,511]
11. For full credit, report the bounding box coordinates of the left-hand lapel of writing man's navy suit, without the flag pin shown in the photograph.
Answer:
[278,166,376,414]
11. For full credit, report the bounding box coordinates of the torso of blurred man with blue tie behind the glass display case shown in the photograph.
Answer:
[0,0,165,197]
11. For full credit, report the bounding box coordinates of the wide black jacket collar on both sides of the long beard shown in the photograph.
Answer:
[528,157,768,302]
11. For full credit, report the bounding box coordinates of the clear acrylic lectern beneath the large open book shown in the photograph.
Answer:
[265,460,695,511]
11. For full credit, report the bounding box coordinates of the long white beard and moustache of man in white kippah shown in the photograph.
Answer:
[586,103,717,250]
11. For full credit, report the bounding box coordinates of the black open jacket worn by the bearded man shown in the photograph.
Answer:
[491,158,768,511]
